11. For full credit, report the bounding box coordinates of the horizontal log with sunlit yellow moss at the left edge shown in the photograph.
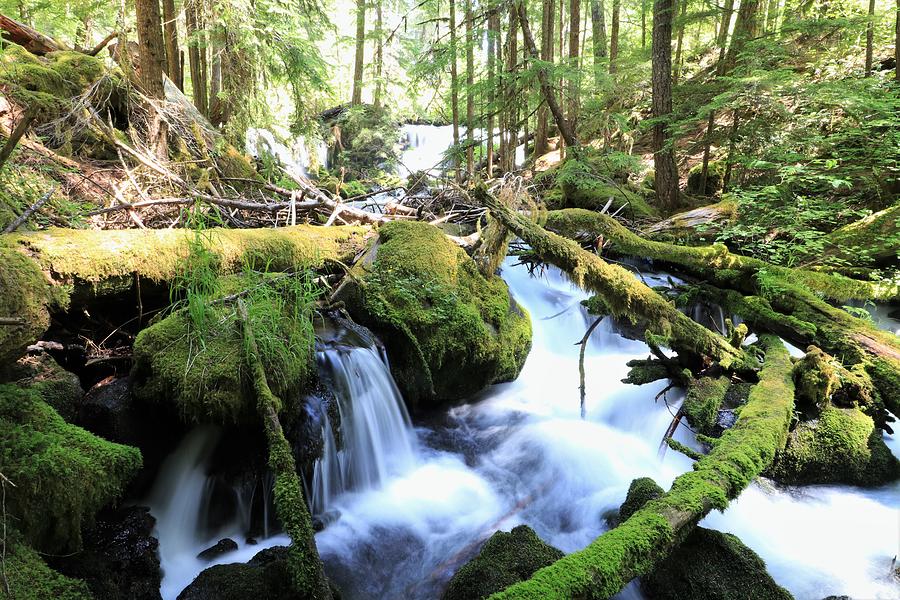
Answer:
[0,225,367,361]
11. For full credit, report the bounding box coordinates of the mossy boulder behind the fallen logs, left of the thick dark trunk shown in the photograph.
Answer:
[557,158,657,218]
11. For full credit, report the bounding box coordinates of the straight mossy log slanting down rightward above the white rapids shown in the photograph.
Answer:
[475,189,749,369]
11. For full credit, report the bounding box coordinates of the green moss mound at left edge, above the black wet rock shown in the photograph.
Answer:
[0,384,141,553]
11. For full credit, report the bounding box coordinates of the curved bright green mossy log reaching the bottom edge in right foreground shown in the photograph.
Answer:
[492,336,794,600]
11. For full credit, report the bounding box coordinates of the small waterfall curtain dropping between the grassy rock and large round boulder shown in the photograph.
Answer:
[312,346,416,513]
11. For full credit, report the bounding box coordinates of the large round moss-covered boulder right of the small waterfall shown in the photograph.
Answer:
[335,221,531,406]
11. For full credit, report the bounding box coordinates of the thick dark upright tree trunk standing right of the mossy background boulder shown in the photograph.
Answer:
[651,0,678,210]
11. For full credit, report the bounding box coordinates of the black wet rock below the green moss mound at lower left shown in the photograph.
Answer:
[48,506,162,600]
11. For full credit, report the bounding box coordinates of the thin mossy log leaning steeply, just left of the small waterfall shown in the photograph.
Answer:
[238,300,331,600]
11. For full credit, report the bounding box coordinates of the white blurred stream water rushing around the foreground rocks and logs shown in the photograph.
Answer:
[153,255,900,600]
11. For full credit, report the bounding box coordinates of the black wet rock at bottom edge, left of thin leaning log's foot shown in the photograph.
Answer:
[178,546,296,600]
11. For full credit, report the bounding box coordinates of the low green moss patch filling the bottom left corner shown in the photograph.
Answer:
[3,533,93,600]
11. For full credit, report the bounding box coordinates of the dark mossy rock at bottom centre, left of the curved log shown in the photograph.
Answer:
[443,525,563,600]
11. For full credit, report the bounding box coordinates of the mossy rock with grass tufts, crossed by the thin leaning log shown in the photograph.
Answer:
[132,277,315,424]
